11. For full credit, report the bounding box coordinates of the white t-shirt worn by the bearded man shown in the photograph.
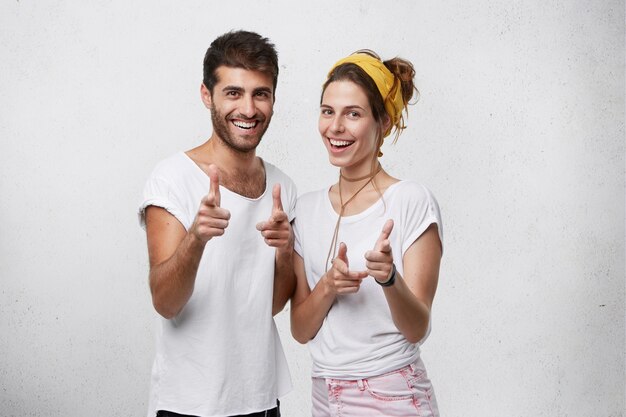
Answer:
[139,152,297,417]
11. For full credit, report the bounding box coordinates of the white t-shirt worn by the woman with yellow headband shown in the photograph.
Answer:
[294,181,443,379]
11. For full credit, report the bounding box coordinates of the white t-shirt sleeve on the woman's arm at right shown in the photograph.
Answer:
[402,185,443,255]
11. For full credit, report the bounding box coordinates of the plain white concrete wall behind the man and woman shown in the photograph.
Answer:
[0,0,625,417]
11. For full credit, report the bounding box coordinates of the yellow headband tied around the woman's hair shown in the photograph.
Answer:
[328,53,404,137]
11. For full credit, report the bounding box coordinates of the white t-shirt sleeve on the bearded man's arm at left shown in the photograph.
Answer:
[138,176,191,229]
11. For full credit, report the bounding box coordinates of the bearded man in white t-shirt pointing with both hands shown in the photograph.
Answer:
[140,31,296,417]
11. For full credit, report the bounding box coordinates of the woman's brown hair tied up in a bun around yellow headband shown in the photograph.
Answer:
[322,49,419,147]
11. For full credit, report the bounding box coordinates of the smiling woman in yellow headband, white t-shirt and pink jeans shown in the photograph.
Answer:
[291,51,442,417]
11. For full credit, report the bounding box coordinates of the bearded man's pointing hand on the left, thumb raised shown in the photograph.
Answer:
[189,165,230,243]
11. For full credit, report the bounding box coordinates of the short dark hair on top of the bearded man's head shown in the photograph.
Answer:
[202,30,278,93]
